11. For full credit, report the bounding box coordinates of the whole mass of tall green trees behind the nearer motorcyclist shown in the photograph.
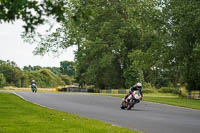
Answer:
[0,0,200,90]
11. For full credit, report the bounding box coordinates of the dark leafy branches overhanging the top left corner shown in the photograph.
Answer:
[0,0,67,33]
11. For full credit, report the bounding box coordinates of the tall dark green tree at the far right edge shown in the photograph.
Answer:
[165,0,200,90]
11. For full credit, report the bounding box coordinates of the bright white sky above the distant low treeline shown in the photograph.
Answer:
[0,21,76,68]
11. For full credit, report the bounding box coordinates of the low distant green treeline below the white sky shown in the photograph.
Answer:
[0,60,74,88]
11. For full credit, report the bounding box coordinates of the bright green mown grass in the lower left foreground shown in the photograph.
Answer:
[0,93,138,133]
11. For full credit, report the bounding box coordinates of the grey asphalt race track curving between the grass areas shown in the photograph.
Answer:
[16,92,200,133]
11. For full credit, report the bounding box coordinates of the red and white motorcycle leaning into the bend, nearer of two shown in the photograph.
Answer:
[121,91,142,110]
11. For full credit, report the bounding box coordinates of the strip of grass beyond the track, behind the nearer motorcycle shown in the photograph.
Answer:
[101,93,200,110]
